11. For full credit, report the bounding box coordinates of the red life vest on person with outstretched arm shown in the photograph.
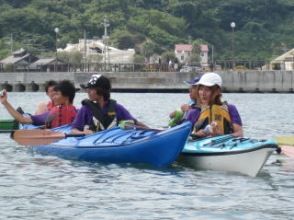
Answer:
[46,105,77,128]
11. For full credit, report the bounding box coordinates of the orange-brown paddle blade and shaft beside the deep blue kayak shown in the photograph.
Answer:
[11,129,85,146]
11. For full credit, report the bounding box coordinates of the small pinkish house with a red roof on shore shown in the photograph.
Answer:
[175,44,208,67]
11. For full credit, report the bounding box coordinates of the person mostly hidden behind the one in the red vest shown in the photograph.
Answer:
[35,80,57,115]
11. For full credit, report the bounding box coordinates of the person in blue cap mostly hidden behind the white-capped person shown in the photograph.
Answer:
[168,76,201,127]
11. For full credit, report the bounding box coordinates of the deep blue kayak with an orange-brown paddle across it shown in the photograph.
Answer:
[33,122,191,167]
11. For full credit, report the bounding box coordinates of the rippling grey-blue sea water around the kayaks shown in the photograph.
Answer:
[0,93,294,219]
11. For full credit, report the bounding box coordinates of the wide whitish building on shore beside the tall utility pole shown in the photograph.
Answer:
[58,39,135,64]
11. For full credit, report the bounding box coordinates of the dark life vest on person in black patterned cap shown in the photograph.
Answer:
[82,99,118,131]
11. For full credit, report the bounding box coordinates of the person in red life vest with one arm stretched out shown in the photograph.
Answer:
[0,80,77,128]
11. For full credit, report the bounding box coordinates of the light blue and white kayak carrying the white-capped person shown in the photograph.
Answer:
[179,135,278,176]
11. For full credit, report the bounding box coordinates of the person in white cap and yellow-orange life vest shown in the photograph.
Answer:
[186,72,243,137]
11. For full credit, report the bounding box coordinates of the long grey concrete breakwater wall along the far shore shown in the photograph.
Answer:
[0,71,294,93]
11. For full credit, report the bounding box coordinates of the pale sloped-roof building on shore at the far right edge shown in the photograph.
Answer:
[269,48,294,70]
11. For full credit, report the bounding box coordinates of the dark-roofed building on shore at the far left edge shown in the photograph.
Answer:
[0,48,38,71]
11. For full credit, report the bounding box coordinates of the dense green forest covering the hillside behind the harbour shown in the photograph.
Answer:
[0,0,294,60]
